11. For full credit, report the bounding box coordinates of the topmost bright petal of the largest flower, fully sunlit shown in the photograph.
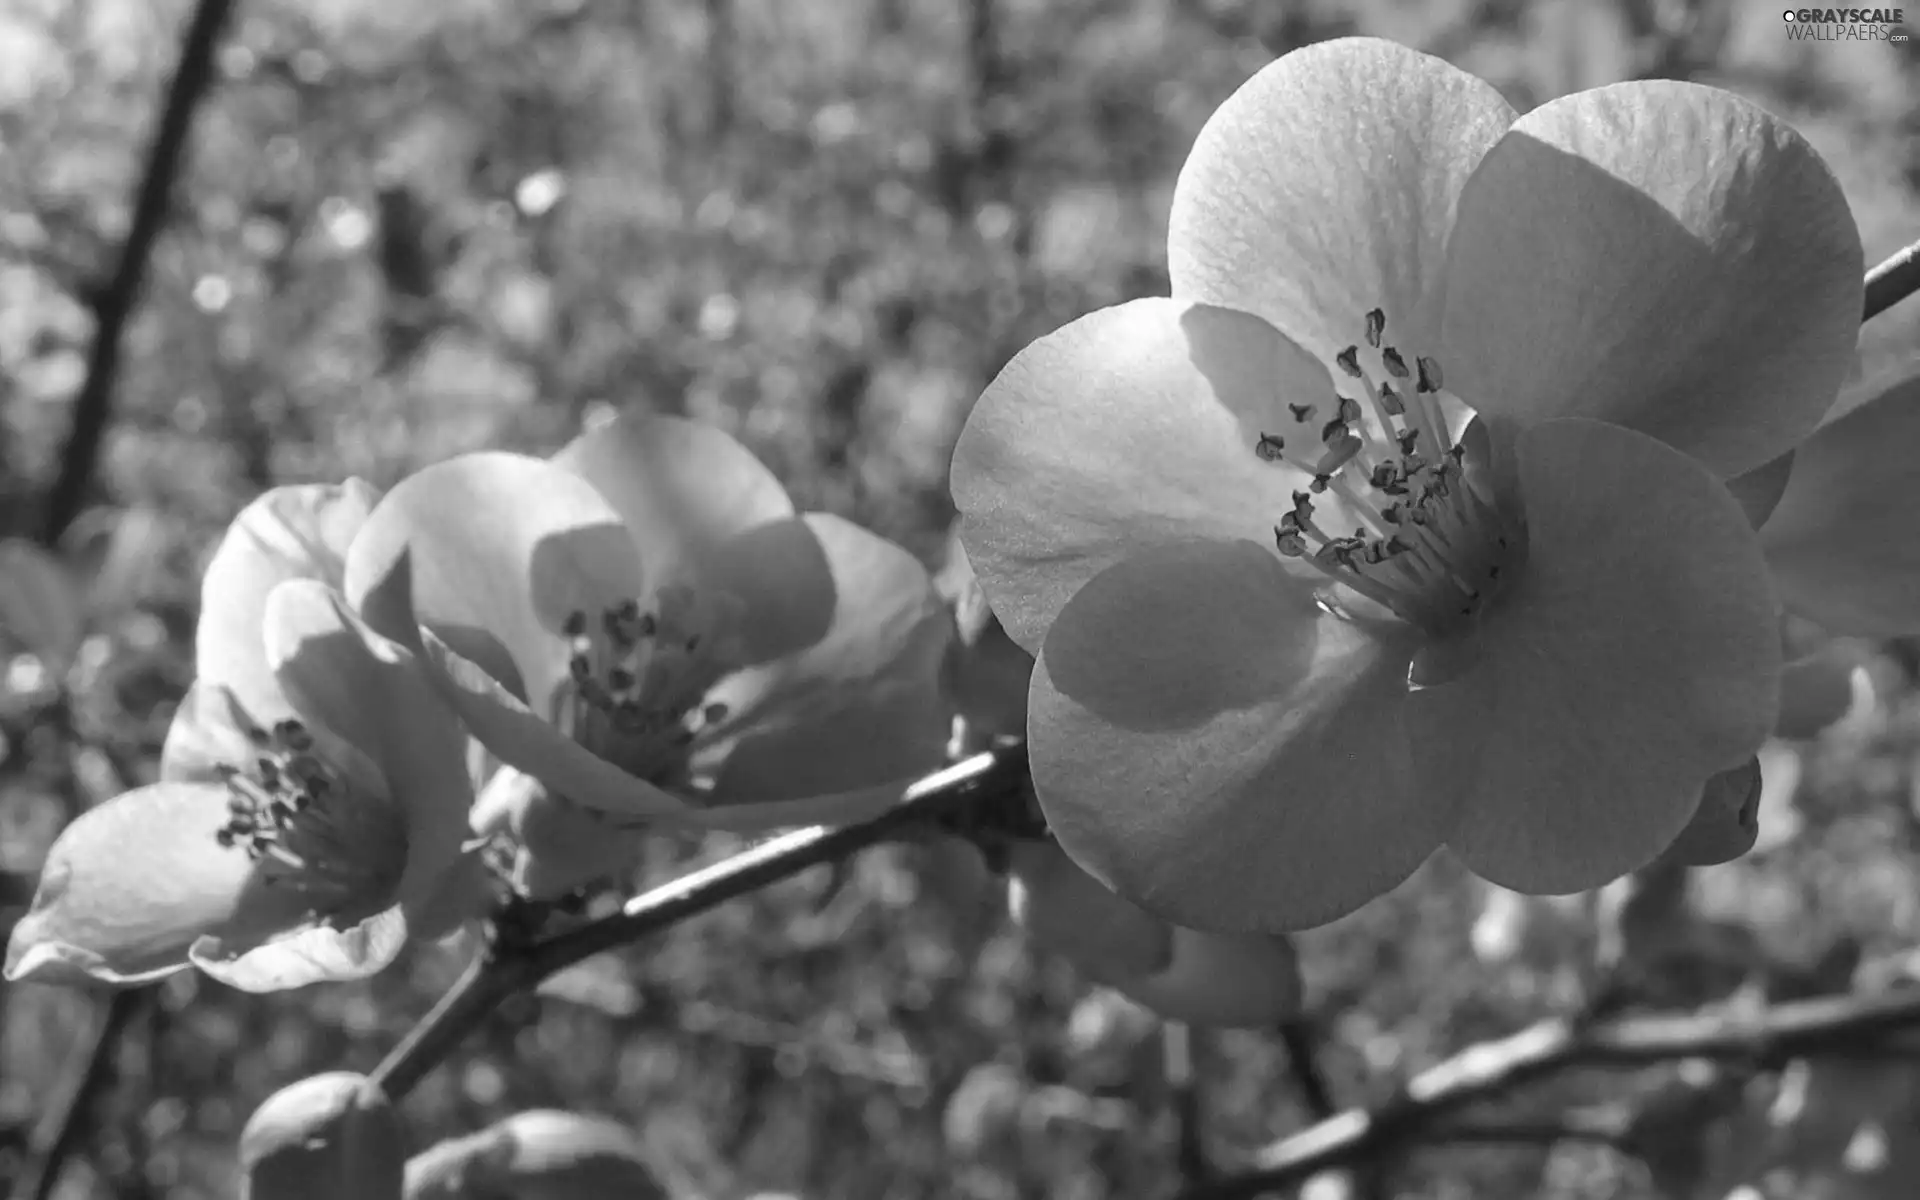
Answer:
[1167,38,1513,361]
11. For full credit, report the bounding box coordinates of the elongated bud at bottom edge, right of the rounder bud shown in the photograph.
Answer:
[405,1108,666,1200]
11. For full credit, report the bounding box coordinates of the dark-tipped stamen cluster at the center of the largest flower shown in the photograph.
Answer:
[1254,309,1519,634]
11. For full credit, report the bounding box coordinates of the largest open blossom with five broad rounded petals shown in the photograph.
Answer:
[952,38,1860,931]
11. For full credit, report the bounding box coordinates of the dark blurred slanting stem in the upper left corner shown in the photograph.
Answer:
[40,0,234,545]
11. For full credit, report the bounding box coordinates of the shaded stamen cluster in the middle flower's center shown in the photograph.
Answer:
[559,584,741,785]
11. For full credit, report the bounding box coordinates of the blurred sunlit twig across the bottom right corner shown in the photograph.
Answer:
[1179,989,1920,1200]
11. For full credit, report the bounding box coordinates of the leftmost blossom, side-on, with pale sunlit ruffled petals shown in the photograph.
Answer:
[6,480,478,991]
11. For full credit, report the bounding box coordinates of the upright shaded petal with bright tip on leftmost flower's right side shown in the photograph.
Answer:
[267,580,472,906]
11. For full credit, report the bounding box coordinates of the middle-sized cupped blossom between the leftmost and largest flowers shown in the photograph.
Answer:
[348,417,952,891]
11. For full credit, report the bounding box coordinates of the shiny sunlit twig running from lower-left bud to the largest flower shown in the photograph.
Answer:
[371,747,1029,1100]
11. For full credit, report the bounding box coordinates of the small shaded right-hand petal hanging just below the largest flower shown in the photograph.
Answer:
[1112,927,1302,1029]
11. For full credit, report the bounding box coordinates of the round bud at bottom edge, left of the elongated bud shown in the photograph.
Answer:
[240,1071,407,1200]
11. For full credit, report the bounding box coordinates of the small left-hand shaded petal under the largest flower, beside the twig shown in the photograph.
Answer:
[1008,841,1173,983]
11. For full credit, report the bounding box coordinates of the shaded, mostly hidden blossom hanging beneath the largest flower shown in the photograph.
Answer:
[1008,843,1302,1029]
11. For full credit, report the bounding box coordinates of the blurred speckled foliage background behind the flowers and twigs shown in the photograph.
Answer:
[0,0,1920,1200]
